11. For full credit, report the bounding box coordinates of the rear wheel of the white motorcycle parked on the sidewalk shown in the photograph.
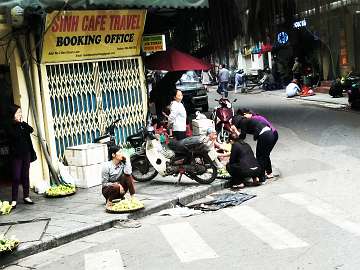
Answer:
[186,154,217,184]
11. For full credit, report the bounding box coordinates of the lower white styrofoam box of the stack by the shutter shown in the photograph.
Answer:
[69,163,103,188]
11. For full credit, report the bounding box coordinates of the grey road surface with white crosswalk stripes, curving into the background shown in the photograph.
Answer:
[4,92,360,270]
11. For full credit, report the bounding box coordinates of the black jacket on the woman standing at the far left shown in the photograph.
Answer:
[8,122,36,161]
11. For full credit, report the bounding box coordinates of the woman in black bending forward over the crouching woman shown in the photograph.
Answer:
[231,115,274,182]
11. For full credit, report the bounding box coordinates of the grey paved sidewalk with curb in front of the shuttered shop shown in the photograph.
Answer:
[0,176,229,268]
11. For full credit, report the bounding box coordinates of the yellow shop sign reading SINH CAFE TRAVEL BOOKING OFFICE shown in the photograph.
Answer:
[41,10,146,63]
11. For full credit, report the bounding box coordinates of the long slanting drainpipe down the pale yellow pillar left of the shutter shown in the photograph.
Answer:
[16,34,61,185]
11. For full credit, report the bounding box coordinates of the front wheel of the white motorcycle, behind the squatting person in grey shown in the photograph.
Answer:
[131,156,158,182]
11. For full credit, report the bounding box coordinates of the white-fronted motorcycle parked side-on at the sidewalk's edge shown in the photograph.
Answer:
[127,128,217,184]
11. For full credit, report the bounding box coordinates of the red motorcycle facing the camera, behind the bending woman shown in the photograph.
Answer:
[211,97,237,143]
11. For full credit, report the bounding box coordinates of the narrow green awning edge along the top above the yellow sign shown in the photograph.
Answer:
[0,0,209,9]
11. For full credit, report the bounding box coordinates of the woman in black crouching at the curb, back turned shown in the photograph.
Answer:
[226,133,261,187]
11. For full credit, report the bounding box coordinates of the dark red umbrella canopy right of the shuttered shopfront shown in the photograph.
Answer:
[145,48,211,71]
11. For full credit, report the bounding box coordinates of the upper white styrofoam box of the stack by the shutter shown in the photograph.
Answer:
[65,143,108,166]
